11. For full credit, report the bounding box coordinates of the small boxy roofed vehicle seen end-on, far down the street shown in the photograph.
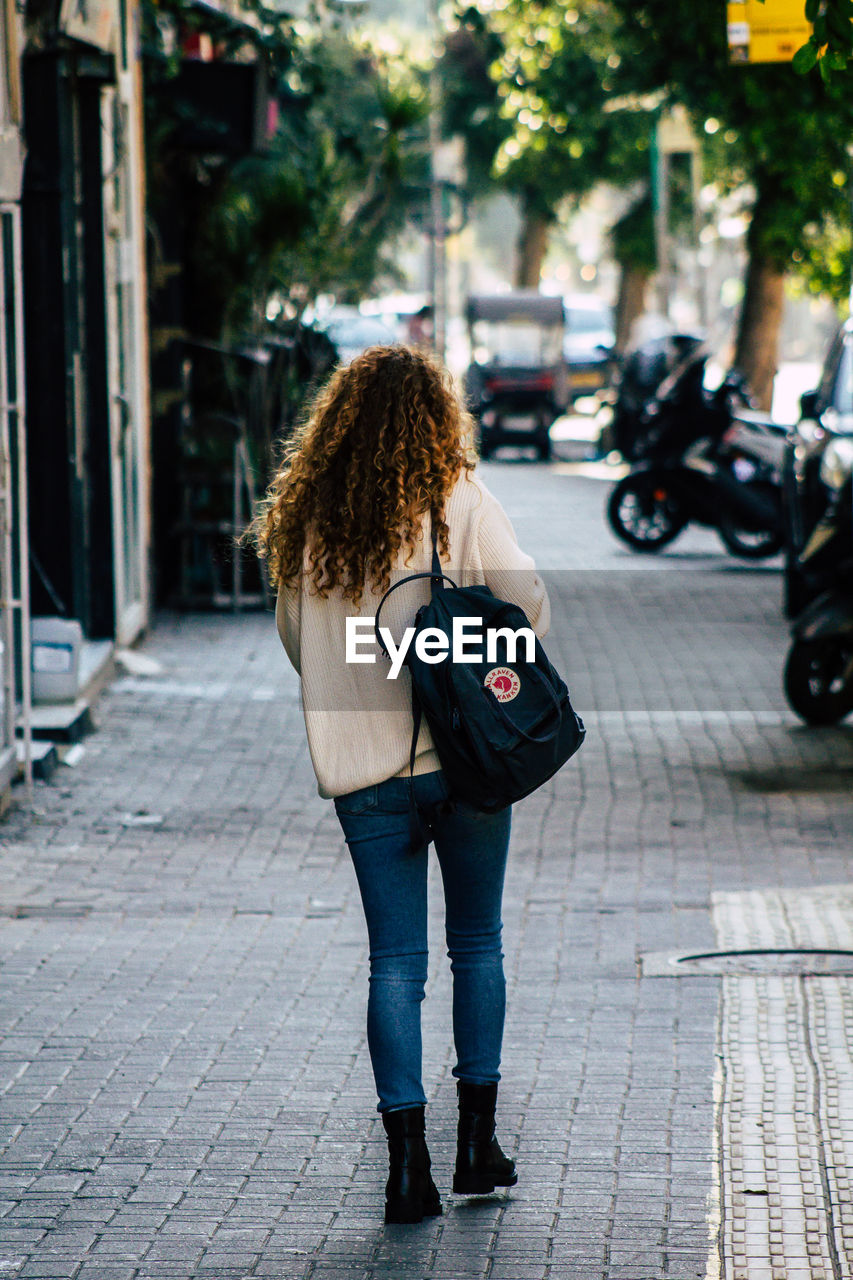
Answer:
[465,289,569,460]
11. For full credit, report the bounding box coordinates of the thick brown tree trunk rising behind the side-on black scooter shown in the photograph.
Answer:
[734,244,785,411]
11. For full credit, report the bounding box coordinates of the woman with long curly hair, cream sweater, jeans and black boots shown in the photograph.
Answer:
[252,347,549,1222]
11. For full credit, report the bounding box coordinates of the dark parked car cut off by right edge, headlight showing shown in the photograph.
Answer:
[784,319,853,618]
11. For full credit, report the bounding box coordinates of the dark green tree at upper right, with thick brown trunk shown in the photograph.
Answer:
[604,0,853,406]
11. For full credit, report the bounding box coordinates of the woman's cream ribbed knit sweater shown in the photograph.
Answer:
[275,472,551,797]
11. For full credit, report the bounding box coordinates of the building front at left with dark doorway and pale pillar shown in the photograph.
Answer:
[20,0,150,645]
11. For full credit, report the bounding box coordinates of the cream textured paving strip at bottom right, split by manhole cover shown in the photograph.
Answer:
[713,884,853,1280]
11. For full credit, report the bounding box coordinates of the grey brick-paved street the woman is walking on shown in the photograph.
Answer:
[0,461,853,1280]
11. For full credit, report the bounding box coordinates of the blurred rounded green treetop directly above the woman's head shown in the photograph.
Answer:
[195,33,428,335]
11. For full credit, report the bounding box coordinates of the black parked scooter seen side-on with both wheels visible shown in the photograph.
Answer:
[607,347,786,559]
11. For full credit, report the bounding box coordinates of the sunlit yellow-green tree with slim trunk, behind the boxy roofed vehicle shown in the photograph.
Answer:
[442,0,647,288]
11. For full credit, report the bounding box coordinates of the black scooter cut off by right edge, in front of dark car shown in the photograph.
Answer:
[784,438,853,724]
